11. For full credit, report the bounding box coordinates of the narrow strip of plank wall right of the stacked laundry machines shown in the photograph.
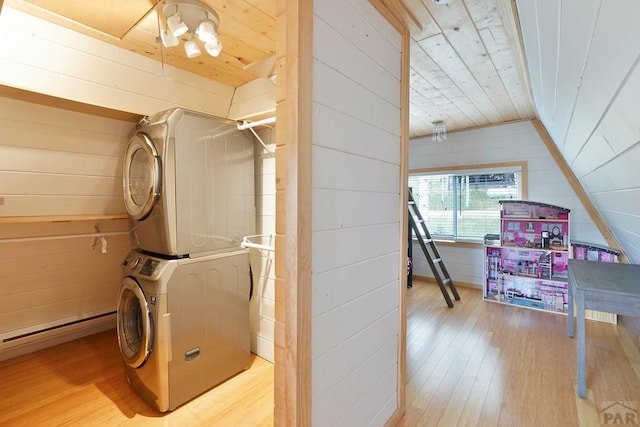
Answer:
[249,128,276,362]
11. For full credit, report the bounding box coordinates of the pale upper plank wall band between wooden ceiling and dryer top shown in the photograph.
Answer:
[0,6,234,117]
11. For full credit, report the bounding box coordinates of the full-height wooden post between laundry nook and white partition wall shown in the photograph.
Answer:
[274,0,313,426]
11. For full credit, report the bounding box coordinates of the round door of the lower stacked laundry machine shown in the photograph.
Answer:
[117,277,153,368]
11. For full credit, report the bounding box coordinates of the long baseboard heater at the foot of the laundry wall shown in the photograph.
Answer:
[0,311,116,361]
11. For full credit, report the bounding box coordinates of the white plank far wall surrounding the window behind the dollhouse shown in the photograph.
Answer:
[409,121,607,287]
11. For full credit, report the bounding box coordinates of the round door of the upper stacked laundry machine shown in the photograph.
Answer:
[122,132,162,221]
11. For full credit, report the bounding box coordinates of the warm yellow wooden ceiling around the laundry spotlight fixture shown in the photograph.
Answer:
[5,0,276,87]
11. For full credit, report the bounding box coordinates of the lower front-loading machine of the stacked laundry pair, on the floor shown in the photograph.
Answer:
[117,249,252,412]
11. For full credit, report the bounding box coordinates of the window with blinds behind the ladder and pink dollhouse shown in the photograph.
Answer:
[409,165,523,240]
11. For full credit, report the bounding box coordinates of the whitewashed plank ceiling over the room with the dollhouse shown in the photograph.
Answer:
[404,0,535,137]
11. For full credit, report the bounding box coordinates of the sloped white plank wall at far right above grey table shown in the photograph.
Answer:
[517,0,640,263]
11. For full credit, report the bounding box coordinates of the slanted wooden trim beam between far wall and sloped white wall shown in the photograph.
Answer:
[531,119,629,263]
